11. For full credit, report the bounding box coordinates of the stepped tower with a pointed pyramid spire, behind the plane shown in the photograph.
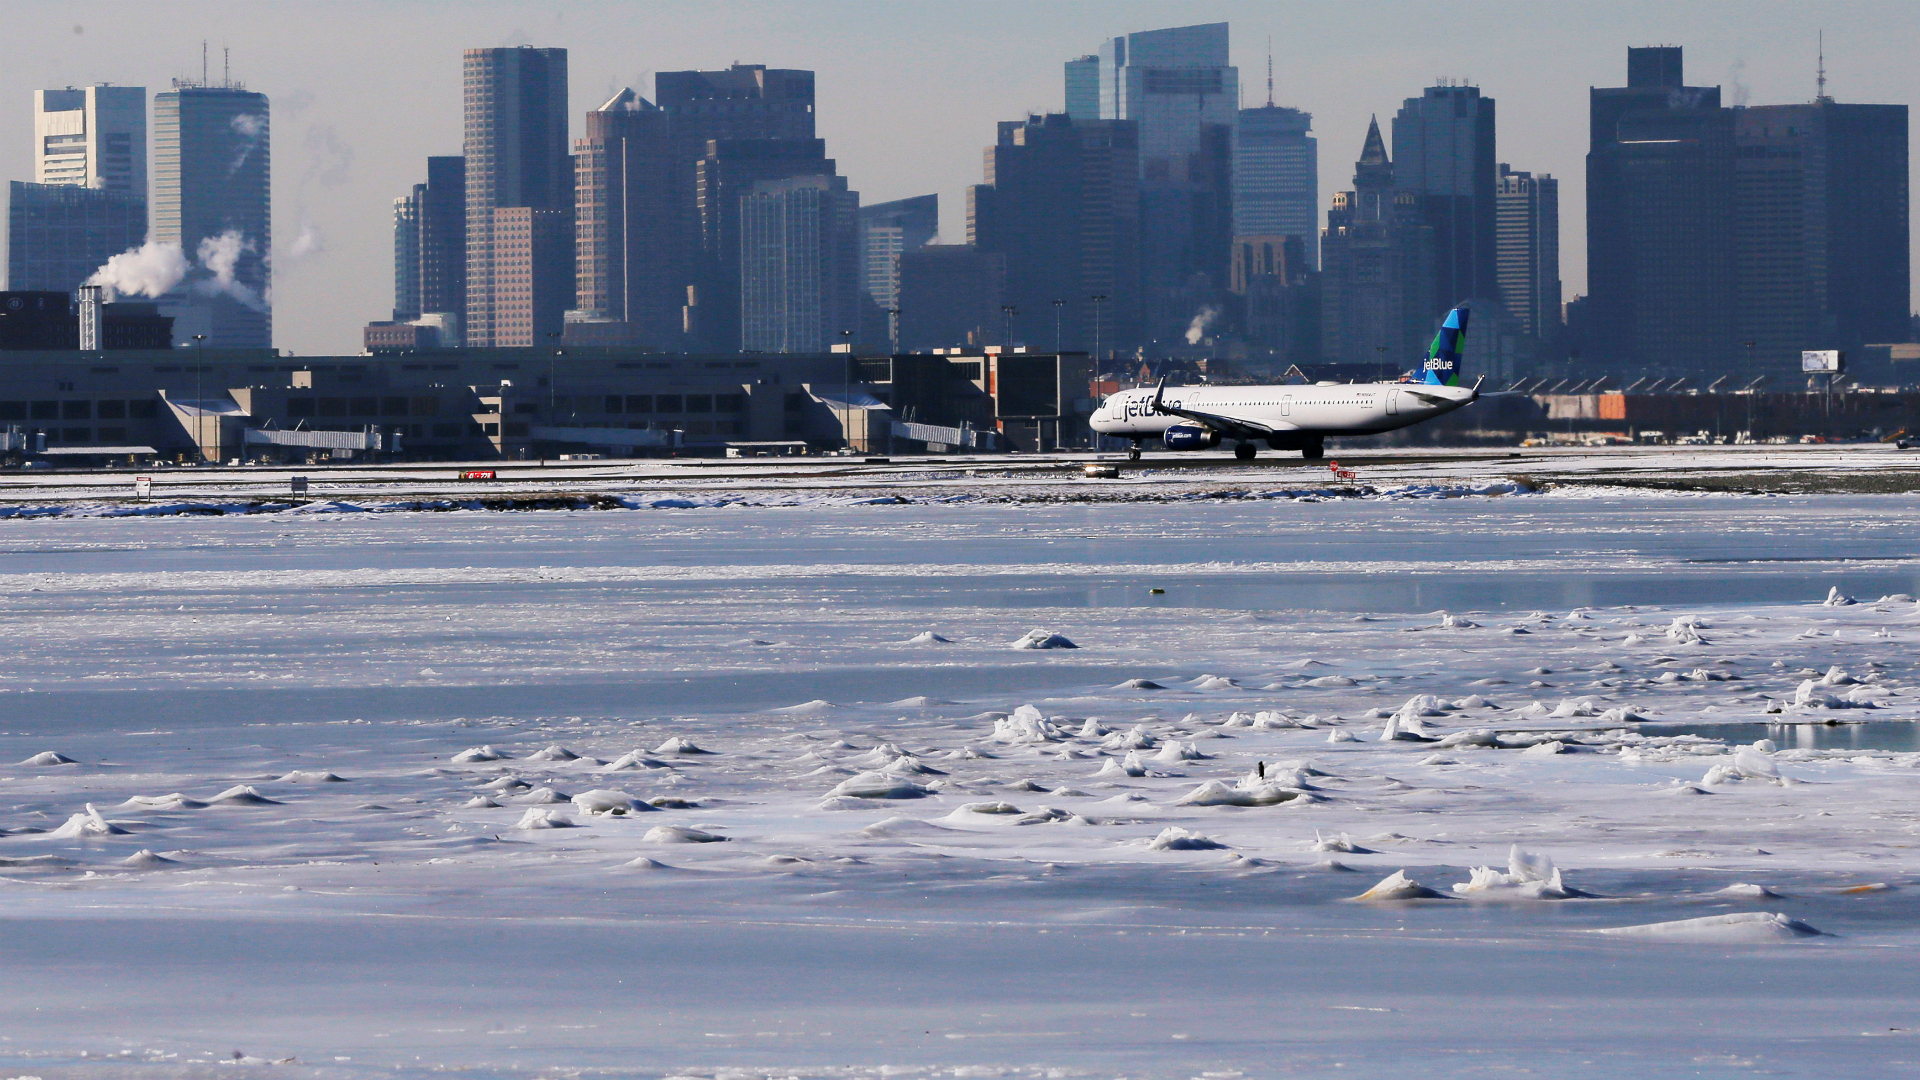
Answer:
[1321,121,1434,365]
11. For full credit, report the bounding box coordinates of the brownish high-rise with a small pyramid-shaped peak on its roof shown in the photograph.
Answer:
[568,88,691,348]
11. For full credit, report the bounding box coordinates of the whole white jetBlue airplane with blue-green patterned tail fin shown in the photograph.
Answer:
[1089,307,1480,461]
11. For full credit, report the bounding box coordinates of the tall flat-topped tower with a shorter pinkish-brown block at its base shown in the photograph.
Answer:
[465,46,574,348]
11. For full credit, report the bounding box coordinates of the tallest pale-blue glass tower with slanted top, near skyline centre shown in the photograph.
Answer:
[1090,23,1240,340]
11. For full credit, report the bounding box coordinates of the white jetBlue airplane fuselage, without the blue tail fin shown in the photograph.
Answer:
[1089,382,1476,450]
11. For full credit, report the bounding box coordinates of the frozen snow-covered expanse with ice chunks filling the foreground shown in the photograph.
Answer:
[0,491,1920,1080]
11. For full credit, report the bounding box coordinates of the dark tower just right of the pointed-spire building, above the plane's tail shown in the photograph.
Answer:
[1394,85,1500,313]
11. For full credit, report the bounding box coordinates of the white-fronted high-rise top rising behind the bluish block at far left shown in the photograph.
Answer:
[33,85,146,198]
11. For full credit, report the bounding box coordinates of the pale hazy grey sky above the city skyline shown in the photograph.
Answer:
[0,0,1920,354]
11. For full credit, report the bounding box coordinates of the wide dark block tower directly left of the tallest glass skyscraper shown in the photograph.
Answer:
[968,113,1140,354]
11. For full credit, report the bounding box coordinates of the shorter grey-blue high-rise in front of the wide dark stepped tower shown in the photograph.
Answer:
[739,175,860,352]
